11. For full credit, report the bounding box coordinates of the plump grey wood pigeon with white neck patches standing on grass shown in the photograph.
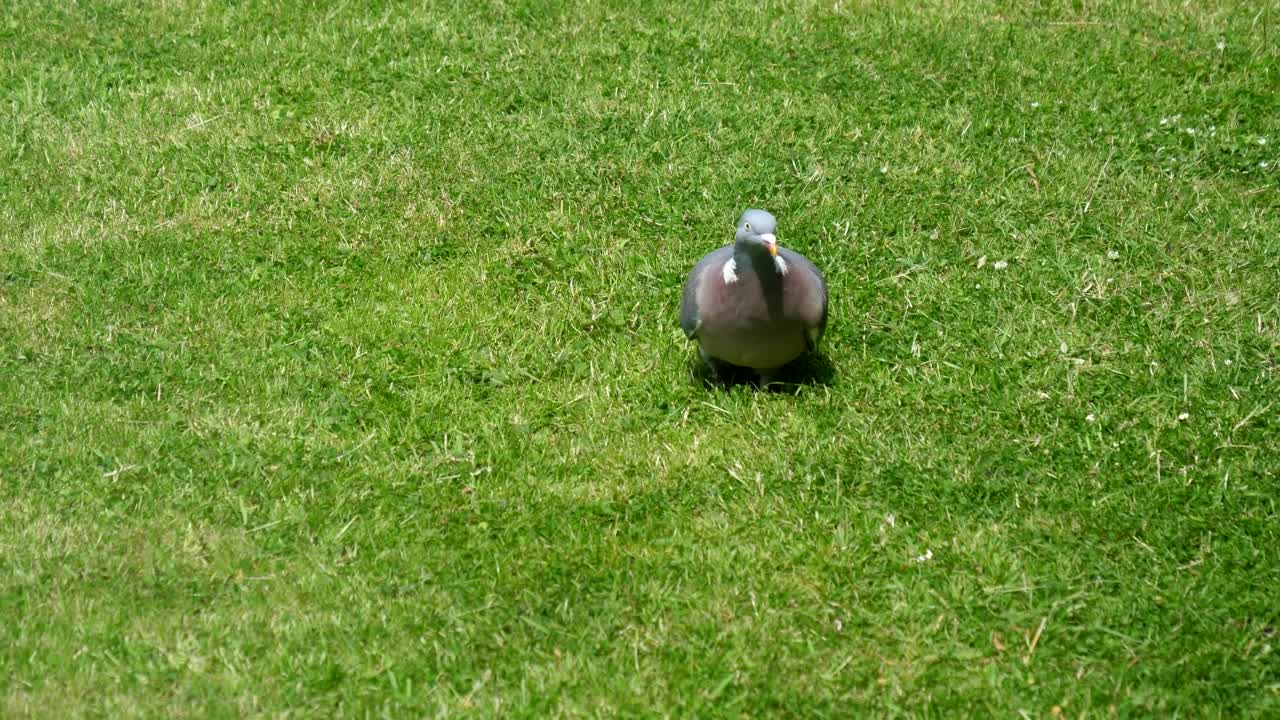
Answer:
[680,209,827,383]
